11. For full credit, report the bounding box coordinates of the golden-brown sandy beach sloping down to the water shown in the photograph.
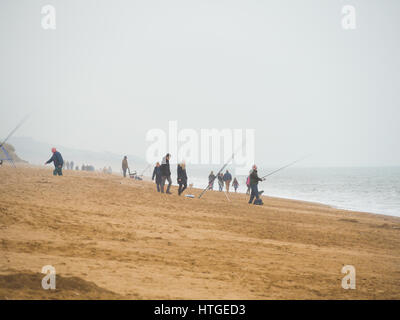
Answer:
[0,166,400,299]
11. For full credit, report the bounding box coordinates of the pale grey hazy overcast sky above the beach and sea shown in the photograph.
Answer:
[0,0,400,166]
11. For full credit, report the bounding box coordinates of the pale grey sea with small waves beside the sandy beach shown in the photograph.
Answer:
[182,167,400,217]
